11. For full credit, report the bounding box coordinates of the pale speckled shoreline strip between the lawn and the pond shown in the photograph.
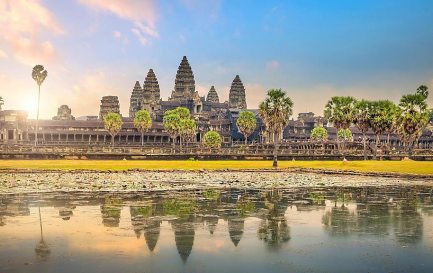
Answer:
[0,169,433,194]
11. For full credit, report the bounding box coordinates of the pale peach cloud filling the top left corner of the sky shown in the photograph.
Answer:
[0,0,65,65]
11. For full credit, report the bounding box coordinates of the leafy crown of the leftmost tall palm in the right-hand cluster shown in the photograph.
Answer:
[324,96,356,129]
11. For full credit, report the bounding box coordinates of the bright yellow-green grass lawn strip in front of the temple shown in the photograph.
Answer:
[0,160,433,175]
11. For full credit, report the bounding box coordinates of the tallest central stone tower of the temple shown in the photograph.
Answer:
[170,56,195,100]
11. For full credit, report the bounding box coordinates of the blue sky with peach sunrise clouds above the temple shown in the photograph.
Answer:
[0,0,433,118]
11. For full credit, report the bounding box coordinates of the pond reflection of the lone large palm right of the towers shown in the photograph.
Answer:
[257,190,290,249]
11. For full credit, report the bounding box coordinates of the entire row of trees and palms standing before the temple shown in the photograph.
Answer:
[21,65,433,167]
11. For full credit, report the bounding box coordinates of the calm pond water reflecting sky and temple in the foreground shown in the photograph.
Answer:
[0,187,433,273]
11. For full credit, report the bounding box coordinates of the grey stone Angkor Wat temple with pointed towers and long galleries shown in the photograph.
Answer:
[0,56,433,147]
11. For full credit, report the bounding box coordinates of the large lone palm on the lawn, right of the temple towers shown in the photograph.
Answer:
[259,89,293,168]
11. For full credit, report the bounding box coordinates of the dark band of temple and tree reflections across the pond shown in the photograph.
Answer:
[0,188,433,262]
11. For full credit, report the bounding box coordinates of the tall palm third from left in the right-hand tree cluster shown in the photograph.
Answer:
[370,100,397,159]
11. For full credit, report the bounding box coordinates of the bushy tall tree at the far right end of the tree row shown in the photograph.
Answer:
[396,85,429,155]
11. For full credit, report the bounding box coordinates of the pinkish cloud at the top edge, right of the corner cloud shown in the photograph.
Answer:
[78,0,159,46]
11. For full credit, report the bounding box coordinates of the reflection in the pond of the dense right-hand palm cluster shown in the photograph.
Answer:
[322,189,423,244]
